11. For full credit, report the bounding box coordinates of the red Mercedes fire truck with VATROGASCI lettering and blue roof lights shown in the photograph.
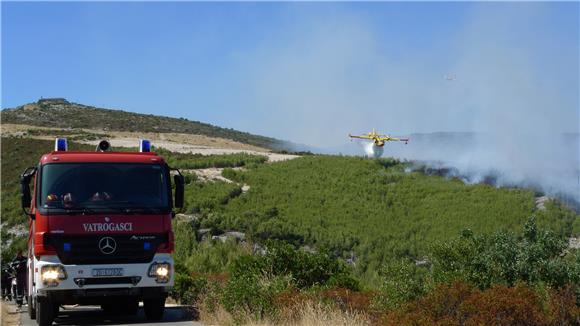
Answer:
[21,138,184,325]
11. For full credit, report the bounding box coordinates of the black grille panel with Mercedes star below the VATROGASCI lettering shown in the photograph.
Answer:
[44,234,167,264]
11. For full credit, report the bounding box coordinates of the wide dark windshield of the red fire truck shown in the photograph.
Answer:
[39,163,169,210]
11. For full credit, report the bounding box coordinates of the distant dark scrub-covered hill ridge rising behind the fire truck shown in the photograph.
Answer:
[1,99,288,150]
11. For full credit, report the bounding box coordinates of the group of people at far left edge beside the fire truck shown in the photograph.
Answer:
[1,251,28,308]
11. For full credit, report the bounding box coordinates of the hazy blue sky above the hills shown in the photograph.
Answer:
[1,2,580,144]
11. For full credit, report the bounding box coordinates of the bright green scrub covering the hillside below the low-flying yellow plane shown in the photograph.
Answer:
[186,156,580,283]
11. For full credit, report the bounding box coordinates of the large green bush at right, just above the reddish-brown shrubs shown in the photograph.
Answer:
[431,218,580,289]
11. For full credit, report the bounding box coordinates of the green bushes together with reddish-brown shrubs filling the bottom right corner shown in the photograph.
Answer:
[373,218,580,325]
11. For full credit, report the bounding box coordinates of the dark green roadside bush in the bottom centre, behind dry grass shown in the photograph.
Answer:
[185,241,358,322]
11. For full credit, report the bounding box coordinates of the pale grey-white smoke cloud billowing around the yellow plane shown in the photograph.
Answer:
[236,3,580,201]
